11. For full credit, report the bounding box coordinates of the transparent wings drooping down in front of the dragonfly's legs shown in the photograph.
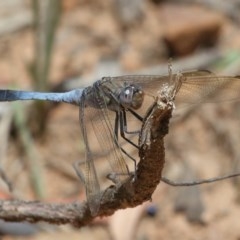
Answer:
[80,89,129,215]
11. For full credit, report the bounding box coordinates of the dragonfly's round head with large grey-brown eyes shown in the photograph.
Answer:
[119,84,144,109]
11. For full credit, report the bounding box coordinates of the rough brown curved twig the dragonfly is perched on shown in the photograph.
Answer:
[0,99,172,227]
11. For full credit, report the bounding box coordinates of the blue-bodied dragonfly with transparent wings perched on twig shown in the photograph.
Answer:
[0,67,240,216]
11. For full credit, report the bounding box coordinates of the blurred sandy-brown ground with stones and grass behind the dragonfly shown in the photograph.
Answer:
[0,0,240,240]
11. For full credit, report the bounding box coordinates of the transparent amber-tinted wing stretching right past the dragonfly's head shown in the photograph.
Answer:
[107,70,240,104]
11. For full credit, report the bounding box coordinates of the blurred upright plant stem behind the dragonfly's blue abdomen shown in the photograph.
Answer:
[30,0,61,134]
